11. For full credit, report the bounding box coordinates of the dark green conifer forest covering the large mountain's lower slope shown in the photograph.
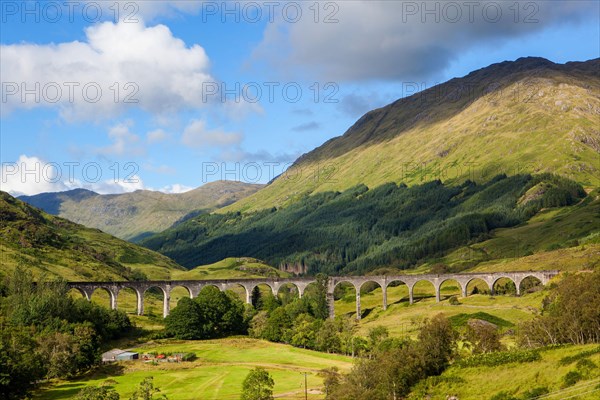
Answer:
[142,174,600,274]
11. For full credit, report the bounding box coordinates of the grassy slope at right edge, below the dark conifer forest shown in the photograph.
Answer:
[436,191,600,271]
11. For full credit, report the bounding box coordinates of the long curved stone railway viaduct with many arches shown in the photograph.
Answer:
[68,271,558,319]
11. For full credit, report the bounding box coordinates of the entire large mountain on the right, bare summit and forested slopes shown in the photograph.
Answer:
[141,58,600,273]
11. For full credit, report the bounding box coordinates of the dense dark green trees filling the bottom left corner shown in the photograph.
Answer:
[0,268,132,400]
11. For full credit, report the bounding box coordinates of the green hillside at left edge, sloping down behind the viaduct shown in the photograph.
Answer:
[0,191,182,281]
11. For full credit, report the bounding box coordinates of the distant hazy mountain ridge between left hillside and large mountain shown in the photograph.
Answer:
[19,181,262,242]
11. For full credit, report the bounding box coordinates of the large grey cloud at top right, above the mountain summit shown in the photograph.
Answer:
[252,0,599,81]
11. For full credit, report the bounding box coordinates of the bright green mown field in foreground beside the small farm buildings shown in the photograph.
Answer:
[36,338,352,400]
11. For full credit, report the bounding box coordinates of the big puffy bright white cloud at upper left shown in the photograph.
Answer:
[0,22,213,121]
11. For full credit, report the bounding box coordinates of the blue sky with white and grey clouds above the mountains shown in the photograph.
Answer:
[0,1,600,194]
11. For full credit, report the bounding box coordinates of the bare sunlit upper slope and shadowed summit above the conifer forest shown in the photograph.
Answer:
[226,58,600,212]
